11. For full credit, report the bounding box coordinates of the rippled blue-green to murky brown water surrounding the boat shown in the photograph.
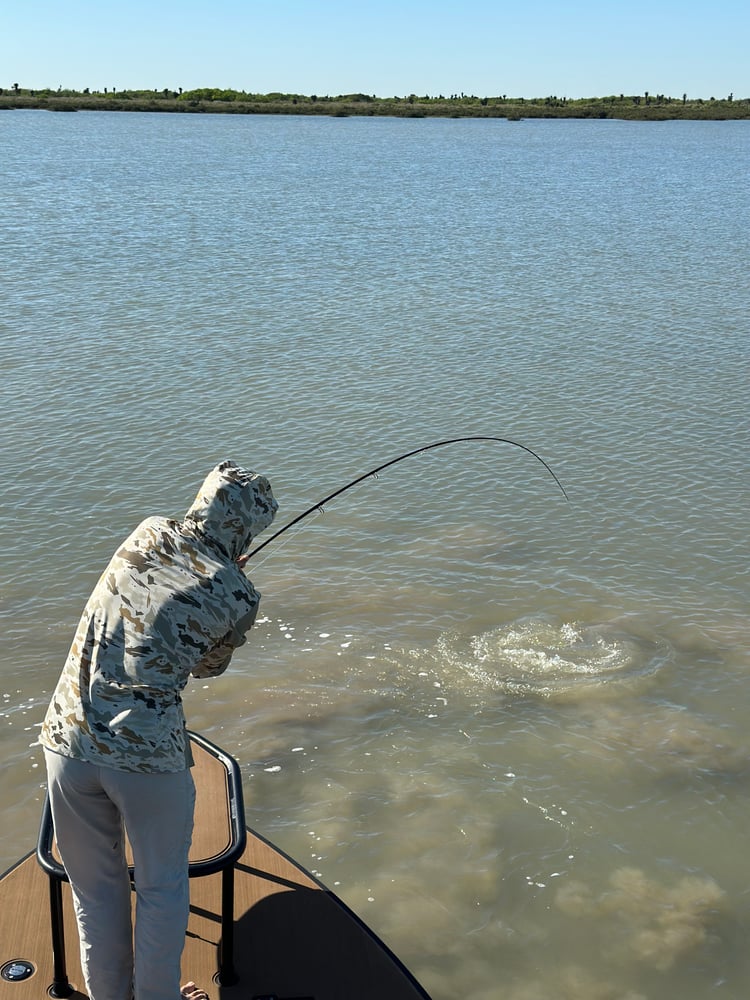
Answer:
[0,112,750,1000]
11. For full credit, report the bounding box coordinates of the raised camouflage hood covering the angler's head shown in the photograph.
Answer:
[183,462,279,560]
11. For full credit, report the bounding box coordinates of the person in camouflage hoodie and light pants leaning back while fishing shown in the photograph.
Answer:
[40,461,278,1000]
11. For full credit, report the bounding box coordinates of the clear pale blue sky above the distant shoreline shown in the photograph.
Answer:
[0,0,750,98]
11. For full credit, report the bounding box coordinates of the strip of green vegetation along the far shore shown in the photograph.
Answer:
[0,84,750,121]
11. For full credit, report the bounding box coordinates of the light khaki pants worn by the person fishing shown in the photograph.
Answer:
[45,750,195,1000]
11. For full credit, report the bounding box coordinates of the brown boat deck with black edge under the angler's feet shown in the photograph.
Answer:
[0,744,429,1000]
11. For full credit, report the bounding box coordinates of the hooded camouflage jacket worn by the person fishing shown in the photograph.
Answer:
[41,462,277,771]
